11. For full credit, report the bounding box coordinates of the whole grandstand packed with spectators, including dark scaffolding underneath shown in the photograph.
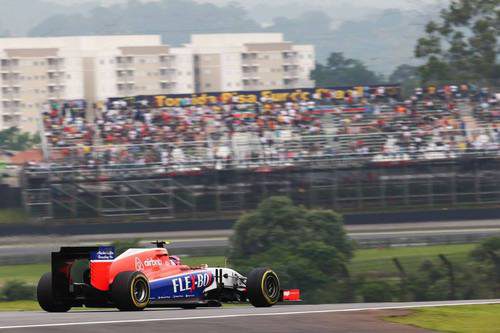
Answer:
[24,85,500,218]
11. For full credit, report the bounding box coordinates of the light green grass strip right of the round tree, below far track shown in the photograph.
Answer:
[349,244,476,276]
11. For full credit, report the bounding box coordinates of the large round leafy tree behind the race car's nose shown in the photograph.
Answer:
[229,197,353,302]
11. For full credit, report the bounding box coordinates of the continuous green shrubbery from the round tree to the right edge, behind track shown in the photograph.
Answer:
[229,197,500,303]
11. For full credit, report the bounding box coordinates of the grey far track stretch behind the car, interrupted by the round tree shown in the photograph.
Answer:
[0,220,500,259]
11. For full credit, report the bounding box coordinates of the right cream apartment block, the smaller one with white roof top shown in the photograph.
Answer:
[186,33,315,92]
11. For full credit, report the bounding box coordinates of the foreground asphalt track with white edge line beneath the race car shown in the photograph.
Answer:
[0,300,500,333]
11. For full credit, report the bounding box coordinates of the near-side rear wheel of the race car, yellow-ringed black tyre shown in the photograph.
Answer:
[111,272,151,311]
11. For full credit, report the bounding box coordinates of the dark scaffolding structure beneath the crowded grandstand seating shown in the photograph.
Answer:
[24,157,500,219]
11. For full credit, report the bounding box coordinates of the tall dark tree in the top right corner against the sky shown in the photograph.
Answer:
[415,0,500,82]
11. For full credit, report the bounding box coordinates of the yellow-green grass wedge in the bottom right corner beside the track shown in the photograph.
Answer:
[385,305,500,333]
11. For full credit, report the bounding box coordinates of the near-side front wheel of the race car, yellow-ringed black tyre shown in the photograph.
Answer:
[247,268,281,308]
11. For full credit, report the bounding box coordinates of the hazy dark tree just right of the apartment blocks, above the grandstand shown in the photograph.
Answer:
[311,52,383,87]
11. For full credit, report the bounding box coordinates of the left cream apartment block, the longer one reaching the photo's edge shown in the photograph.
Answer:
[0,35,194,133]
